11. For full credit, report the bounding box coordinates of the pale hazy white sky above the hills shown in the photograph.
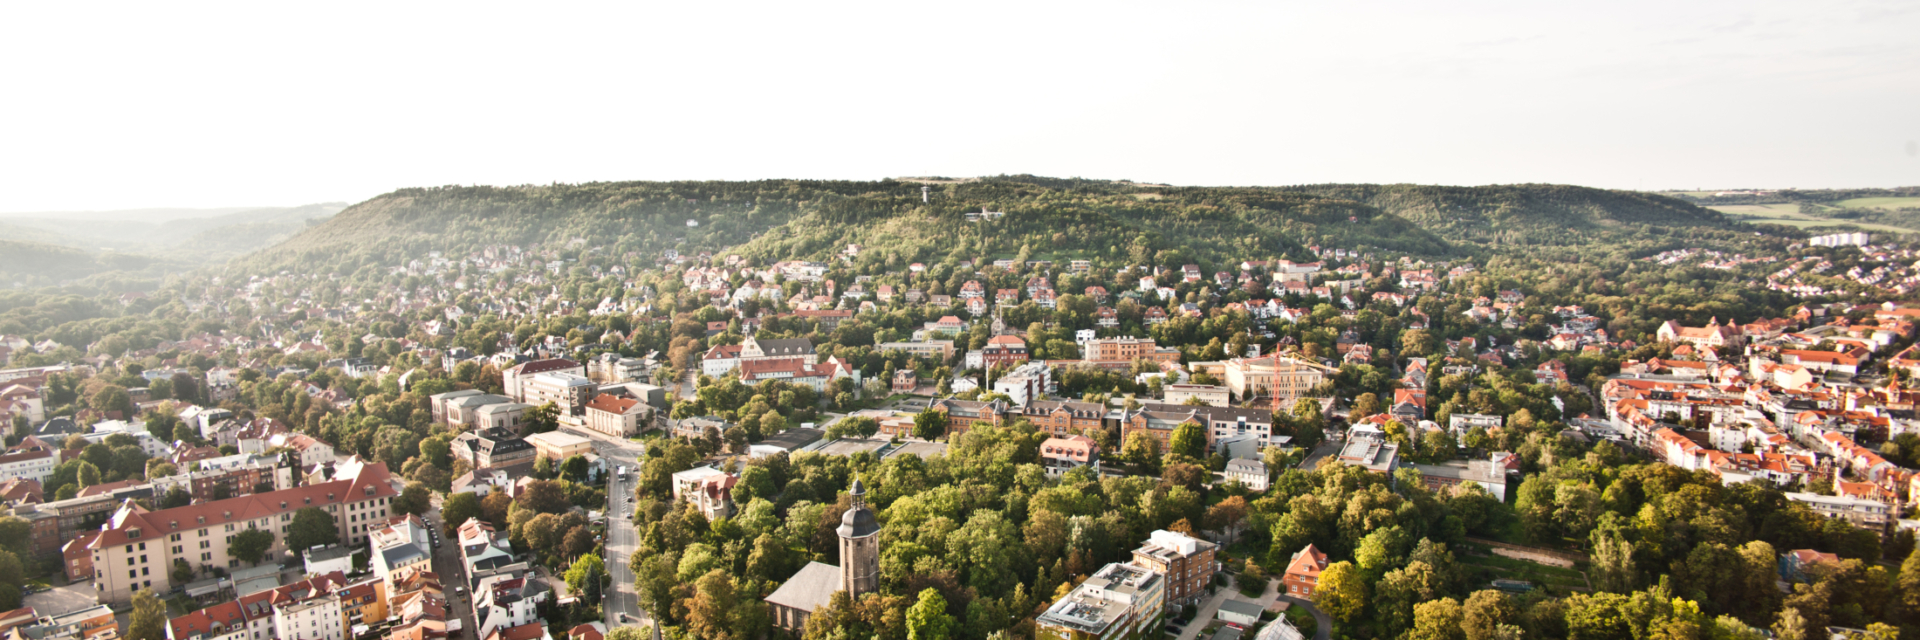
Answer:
[0,0,1920,211]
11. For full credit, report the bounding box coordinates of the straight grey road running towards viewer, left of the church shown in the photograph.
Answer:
[566,420,660,640]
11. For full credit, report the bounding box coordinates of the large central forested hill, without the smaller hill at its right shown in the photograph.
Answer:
[230,177,1452,273]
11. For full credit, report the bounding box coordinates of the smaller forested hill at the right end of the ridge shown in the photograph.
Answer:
[1281,185,1734,248]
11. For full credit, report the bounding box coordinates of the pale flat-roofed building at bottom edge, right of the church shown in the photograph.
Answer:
[1035,563,1169,640]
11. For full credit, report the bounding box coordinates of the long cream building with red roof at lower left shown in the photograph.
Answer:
[90,463,399,603]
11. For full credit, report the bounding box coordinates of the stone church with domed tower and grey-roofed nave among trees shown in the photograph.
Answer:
[766,480,879,632]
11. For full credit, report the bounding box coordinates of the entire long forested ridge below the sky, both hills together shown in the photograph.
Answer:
[230,175,1732,273]
